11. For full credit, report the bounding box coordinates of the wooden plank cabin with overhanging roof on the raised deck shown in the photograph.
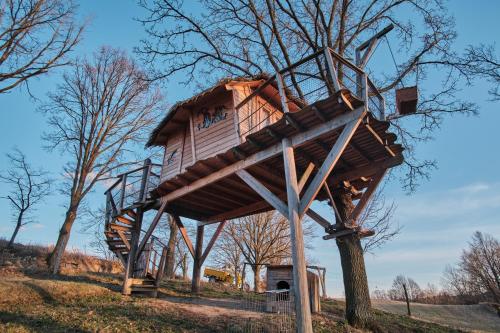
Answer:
[148,76,292,182]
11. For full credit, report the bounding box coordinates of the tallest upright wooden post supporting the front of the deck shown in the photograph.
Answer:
[282,139,313,333]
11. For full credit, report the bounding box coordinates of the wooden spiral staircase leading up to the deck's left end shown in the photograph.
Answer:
[104,160,166,297]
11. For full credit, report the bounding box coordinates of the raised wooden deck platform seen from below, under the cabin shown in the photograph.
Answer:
[151,90,403,223]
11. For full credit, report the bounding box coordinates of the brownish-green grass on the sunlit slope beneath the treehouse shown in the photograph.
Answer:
[0,273,472,333]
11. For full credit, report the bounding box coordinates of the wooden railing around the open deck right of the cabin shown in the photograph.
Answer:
[236,48,385,140]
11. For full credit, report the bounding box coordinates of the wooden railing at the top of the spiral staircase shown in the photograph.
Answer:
[104,159,161,223]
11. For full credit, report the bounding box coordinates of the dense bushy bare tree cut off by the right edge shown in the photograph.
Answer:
[445,231,500,303]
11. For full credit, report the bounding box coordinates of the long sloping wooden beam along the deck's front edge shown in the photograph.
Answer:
[164,107,365,202]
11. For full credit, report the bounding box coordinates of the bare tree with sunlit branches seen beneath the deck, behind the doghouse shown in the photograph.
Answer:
[224,211,313,291]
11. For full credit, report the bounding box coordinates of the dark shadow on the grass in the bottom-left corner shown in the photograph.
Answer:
[0,311,90,333]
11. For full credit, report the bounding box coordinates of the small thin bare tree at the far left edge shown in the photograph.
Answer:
[0,149,52,247]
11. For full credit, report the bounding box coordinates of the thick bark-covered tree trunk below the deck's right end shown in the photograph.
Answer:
[334,193,372,328]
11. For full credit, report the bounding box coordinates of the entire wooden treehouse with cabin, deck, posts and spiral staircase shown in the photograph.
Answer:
[105,48,403,331]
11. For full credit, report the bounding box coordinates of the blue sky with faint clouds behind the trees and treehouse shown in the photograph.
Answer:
[0,0,500,296]
